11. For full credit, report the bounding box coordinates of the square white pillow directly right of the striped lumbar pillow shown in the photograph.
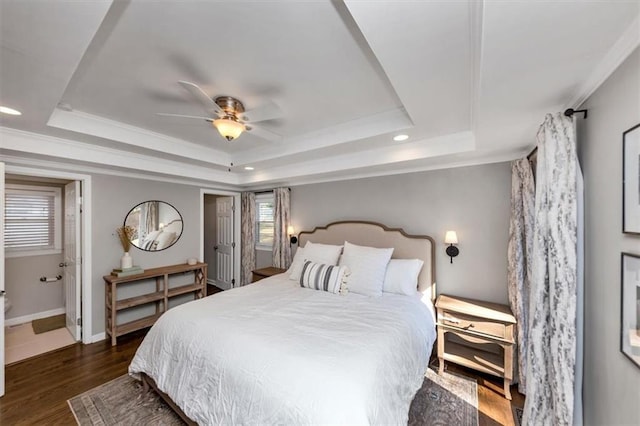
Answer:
[340,241,393,296]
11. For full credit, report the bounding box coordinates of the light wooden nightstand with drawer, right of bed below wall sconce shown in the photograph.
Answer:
[436,294,516,399]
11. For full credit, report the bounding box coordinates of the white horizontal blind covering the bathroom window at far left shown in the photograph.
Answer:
[4,188,56,250]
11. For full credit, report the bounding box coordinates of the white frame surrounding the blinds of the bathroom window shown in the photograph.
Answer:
[2,183,62,258]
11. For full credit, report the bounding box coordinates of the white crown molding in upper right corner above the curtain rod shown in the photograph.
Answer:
[564,17,640,108]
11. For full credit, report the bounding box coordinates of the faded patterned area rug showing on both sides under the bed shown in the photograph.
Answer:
[67,370,478,426]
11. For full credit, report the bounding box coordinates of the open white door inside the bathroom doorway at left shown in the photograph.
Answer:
[64,181,82,340]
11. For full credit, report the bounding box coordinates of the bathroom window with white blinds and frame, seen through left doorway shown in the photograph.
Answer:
[4,184,62,257]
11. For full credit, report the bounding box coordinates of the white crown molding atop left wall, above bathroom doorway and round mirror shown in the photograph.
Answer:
[0,127,238,186]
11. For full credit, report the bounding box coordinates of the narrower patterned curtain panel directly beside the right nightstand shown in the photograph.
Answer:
[507,158,536,393]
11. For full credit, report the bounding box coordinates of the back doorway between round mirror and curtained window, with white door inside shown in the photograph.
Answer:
[200,189,240,294]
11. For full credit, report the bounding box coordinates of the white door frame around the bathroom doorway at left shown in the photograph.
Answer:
[2,163,97,344]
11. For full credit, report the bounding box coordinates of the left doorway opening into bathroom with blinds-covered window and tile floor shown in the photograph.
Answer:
[3,174,81,364]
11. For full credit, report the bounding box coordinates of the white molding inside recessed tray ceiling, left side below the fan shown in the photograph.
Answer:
[47,108,233,167]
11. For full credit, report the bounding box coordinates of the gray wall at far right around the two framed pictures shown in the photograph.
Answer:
[578,49,640,425]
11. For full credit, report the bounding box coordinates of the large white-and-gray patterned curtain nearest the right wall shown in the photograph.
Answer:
[523,113,578,425]
